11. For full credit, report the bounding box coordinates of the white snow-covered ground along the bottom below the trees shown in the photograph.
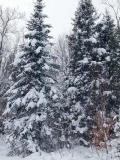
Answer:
[0,136,120,160]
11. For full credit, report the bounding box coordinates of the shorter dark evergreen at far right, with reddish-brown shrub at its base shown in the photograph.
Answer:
[86,12,120,145]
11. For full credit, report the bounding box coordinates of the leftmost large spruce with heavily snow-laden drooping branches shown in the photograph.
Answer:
[4,0,56,156]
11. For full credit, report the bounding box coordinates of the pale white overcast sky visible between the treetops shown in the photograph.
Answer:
[0,0,108,37]
